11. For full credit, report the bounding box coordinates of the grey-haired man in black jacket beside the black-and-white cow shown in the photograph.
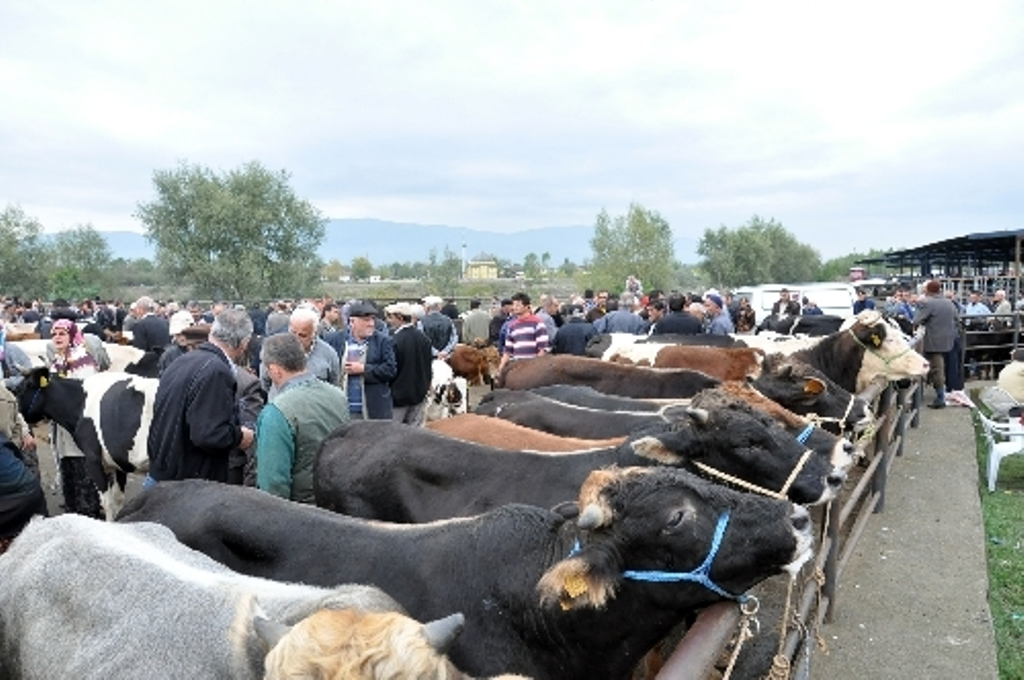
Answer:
[144,309,253,487]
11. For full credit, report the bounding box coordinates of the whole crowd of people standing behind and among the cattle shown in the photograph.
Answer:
[0,277,1012,536]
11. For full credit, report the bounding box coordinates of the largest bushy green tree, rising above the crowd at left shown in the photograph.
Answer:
[135,162,326,300]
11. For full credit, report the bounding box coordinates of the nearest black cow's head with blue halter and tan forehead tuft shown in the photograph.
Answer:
[538,467,811,609]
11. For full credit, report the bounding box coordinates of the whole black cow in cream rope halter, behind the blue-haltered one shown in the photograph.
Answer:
[313,410,849,522]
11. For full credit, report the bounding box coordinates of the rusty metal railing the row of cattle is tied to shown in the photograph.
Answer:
[656,379,923,680]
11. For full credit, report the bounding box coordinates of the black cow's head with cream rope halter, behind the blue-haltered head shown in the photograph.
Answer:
[620,409,847,504]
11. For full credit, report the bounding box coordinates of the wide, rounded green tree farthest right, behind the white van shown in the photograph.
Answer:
[697,215,821,287]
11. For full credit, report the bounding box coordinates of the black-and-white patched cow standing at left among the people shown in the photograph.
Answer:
[18,369,160,520]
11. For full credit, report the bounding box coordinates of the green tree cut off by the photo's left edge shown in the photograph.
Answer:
[0,205,49,300]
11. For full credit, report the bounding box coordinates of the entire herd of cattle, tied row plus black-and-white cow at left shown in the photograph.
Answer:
[0,311,928,679]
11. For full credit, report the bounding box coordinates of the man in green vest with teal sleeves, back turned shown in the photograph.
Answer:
[256,333,348,504]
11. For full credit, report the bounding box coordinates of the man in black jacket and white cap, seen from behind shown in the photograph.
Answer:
[384,302,433,426]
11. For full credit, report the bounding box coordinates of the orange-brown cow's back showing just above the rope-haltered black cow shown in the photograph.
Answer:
[427,413,626,452]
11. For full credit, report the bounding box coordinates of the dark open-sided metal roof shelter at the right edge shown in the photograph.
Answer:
[857,230,1024,300]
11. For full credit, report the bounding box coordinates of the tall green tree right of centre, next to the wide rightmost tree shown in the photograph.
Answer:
[590,203,676,291]
